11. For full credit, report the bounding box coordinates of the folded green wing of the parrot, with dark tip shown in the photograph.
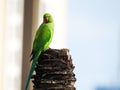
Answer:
[32,24,52,59]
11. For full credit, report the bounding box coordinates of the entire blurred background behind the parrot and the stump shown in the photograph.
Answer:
[0,0,120,90]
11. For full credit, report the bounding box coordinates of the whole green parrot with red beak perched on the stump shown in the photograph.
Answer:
[25,13,54,90]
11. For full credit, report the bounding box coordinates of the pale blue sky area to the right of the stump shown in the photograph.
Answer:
[68,0,120,90]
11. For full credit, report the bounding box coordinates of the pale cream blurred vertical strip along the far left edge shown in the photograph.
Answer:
[0,0,6,90]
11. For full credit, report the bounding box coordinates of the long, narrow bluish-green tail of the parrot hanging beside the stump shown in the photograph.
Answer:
[25,51,41,90]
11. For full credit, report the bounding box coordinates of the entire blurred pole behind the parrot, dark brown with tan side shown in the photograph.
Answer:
[21,0,39,90]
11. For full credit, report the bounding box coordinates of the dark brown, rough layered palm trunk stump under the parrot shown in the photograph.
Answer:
[32,49,76,90]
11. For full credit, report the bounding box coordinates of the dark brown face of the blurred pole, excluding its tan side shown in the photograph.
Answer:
[21,0,34,90]
